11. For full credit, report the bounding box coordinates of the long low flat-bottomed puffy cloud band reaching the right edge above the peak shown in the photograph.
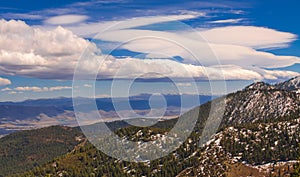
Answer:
[77,55,299,80]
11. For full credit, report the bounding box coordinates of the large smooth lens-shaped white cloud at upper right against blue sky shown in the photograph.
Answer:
[199,26,297,49]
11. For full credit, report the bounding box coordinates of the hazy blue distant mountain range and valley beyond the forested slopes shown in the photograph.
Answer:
[0,94,216,136]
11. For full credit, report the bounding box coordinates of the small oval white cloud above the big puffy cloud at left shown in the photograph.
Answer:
[44,14,89,25]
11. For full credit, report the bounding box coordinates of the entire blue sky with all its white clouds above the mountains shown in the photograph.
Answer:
[0,0,300,101]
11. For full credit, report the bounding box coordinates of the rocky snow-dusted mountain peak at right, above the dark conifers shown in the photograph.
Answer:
[223,82,300,125]
